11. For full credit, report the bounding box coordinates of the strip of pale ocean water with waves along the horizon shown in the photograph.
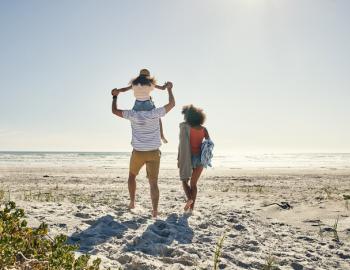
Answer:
[0,152,350,169]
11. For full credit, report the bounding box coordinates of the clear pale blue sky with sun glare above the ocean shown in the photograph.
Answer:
[0,0,350,153]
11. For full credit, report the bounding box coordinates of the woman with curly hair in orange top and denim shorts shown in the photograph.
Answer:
[178,105,209,211]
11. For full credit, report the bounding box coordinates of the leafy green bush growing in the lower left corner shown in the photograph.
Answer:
[0,201,101,270]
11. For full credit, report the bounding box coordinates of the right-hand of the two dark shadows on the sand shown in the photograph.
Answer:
[124,214,193,257]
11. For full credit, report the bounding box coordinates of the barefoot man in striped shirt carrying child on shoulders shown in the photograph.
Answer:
[112,82,175,218]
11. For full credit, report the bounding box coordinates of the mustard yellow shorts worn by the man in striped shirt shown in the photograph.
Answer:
[129,150,161,180]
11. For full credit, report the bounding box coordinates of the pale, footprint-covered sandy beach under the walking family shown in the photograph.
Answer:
[0,155,350,270]
